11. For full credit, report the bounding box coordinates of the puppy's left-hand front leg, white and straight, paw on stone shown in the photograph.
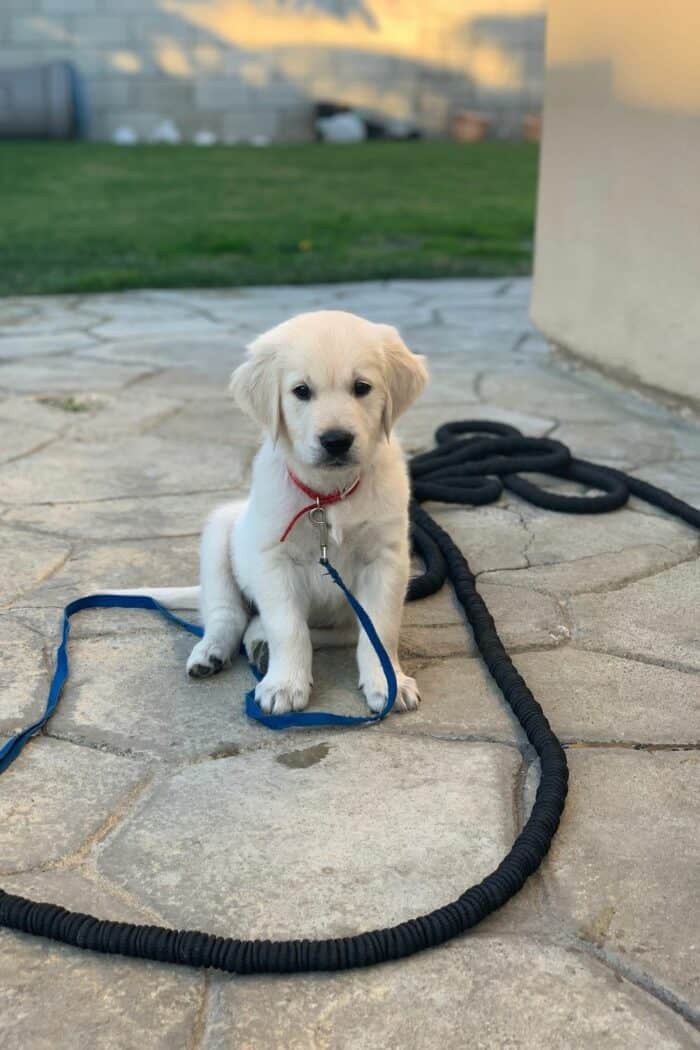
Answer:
[250,561,312,714]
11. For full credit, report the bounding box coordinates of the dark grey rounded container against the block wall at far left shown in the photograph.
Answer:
[0,62,86,139]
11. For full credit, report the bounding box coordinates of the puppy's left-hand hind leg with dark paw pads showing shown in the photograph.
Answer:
[187,506,249,678]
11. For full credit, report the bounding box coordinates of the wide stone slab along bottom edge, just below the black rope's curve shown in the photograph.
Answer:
[203,935,699,1050]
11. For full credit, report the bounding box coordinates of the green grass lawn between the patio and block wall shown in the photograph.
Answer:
[0,143,537,294]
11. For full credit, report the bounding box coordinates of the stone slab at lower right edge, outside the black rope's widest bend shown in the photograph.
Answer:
[543,749,700,1008]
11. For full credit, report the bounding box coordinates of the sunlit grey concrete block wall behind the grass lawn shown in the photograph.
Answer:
[0,0,544,140]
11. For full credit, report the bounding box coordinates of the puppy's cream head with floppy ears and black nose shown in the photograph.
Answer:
[231,310,427,471]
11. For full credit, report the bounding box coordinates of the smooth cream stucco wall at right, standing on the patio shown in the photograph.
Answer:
[532,0,700,399]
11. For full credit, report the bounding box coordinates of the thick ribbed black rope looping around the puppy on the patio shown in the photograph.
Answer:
[0,420,700,973]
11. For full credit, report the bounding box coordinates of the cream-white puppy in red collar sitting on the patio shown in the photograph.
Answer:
[132,311,427,714]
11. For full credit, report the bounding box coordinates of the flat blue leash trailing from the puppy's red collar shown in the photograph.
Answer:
[0,562,397,773]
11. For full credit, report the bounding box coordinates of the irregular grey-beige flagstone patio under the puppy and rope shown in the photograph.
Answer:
[0,280,700,1050]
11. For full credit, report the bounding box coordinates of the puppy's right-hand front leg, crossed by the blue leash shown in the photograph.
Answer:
[357,550,421,712]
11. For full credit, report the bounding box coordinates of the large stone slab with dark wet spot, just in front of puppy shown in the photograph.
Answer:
[98,732,519,938]
